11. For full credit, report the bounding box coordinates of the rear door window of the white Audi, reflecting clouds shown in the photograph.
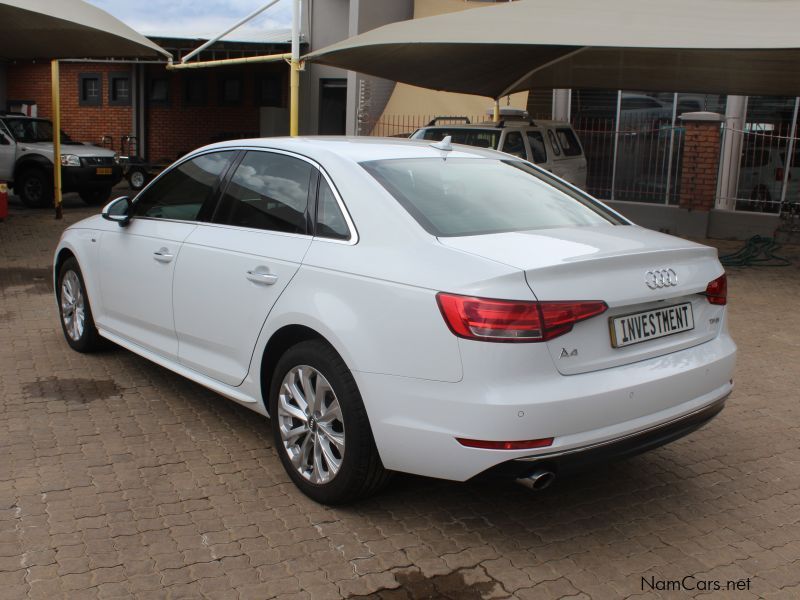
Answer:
[214,152,314,233]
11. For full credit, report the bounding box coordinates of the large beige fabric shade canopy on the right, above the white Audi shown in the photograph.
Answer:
[305,0,800,98]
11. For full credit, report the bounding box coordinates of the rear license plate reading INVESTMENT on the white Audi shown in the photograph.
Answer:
[609,302,694,348]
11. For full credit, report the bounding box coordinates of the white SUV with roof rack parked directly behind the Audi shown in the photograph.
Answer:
[411,118,586,188]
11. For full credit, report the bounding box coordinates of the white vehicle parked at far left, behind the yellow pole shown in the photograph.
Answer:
[0,114,122,207]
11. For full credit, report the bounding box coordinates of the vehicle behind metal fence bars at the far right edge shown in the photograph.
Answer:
[738,144,800,212]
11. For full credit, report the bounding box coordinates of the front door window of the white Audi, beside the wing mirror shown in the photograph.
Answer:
[133,151,236,221]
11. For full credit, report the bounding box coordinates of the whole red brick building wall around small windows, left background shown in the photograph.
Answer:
[8,62,288,162]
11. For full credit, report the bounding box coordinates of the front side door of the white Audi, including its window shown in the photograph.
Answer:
[97,151,236,360]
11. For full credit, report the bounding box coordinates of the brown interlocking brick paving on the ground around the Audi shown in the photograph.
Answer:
[0,199,800,600]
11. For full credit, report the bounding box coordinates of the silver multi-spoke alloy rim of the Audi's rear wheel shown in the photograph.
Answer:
[277,365,345,484]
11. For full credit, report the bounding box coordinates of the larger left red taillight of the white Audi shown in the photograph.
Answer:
[436,293,608,342]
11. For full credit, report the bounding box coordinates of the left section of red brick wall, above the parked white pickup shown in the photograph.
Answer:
[8,63,133,150]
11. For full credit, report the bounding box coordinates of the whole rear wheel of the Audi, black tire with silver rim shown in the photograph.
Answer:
[269,340,390,504]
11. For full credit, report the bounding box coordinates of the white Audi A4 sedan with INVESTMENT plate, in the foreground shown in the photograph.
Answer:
[54,138,736,503]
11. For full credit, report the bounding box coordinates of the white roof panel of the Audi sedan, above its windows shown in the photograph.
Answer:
[192,136,509,163]
